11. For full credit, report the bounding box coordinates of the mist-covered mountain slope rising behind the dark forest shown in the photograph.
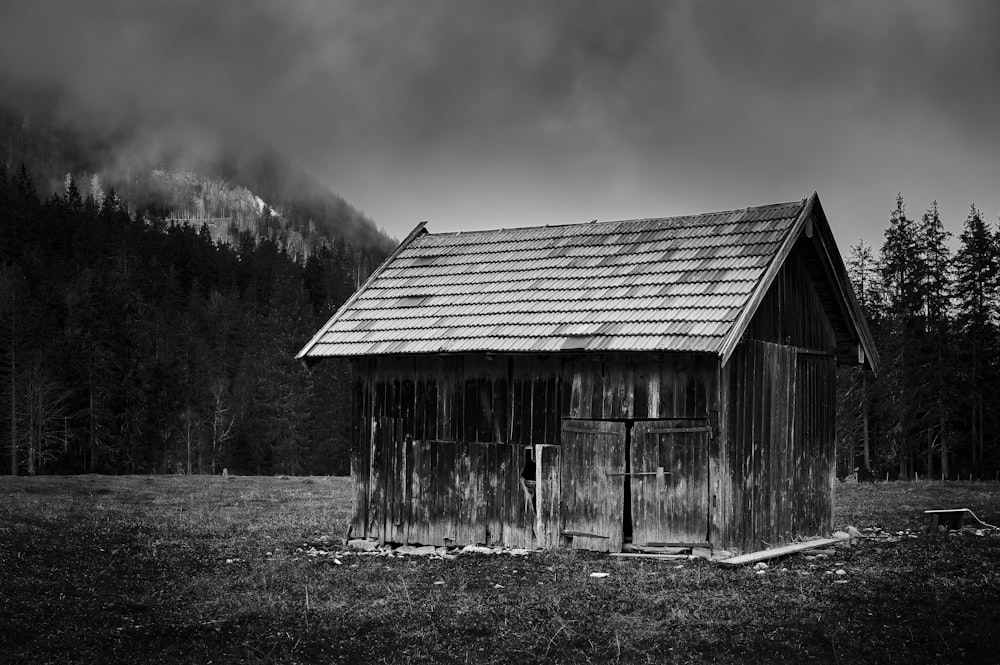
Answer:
[0,93,395,255]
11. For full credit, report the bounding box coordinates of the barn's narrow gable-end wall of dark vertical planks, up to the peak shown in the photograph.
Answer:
[713,239,836,551]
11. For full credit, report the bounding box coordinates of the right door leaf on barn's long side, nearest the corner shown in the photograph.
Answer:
[629,420,712,546]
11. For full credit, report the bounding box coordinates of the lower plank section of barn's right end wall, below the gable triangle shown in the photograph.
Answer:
[724,340,835,551]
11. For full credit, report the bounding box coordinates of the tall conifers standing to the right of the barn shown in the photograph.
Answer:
[838,195,1000,479]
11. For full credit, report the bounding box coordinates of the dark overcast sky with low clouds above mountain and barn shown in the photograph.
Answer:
[0,0,1000,246]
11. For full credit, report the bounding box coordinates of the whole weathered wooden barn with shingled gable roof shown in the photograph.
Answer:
[298,194,877,552]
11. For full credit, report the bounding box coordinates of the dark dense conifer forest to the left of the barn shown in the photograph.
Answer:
[0,167,385,474]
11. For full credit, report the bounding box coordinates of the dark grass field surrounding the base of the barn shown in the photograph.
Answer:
[0,476,1000,664]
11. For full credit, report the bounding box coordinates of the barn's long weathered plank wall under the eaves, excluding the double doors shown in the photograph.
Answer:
[352,353,719,547]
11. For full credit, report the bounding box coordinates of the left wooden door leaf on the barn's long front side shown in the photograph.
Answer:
[560,420,625,552]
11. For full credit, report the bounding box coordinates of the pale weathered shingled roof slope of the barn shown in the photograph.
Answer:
[298,194,876,368]
